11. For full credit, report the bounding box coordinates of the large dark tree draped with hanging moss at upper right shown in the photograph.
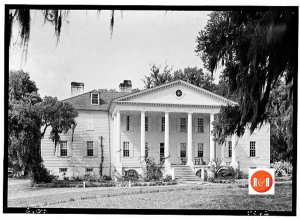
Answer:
[196,8,298,136]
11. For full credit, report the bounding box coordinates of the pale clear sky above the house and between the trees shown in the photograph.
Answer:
[10,10,209,100]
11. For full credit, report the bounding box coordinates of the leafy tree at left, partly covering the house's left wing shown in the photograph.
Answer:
[8,71,78,182]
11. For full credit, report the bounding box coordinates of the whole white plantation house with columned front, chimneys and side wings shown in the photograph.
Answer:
[41,80,270,180]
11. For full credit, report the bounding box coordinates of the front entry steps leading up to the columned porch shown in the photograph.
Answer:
[171,165,203,183]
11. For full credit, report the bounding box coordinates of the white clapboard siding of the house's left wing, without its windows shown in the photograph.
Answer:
[41,110,111,175]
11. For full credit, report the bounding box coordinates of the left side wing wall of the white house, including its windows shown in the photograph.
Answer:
[41,110,111,177]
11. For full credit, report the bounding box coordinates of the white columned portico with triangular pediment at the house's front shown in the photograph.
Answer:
[110,81,238,176]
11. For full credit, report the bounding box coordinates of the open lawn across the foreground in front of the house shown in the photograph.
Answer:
[8,180,292,211]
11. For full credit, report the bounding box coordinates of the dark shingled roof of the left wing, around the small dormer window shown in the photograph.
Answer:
[62,90,129,111]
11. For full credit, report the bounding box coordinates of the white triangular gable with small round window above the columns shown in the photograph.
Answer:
[114,80,237,106]
